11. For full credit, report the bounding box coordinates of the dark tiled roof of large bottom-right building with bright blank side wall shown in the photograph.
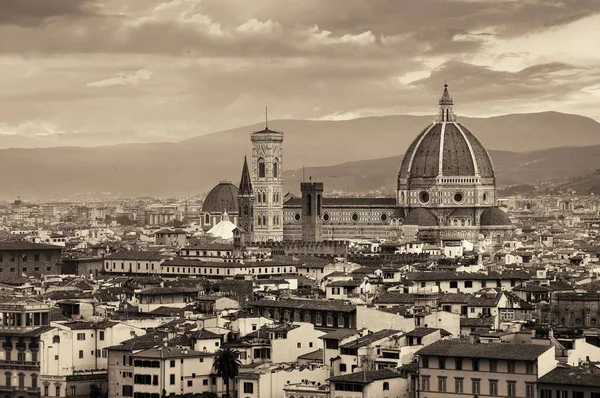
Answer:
[416,340,554,361]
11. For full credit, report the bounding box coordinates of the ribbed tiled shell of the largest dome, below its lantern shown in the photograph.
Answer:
[400,122,494,178]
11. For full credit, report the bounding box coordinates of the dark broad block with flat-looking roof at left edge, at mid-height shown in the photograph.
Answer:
[0,240,62,280]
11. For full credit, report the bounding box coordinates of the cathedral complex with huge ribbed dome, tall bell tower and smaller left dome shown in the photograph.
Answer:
[202,85,513,245]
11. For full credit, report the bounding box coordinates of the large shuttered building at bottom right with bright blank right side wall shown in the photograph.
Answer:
[416,340,557,398]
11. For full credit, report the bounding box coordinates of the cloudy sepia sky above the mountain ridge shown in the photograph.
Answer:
[0,0,600,145]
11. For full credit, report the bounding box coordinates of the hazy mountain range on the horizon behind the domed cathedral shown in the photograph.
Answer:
[0,112,600,199]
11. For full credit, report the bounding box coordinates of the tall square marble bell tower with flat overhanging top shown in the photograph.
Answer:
[250,113,283,242]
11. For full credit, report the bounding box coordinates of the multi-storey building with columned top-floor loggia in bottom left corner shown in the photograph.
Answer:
[0,299,51,398]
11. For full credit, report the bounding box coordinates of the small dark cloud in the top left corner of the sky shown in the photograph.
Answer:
[0,0,97,27]
